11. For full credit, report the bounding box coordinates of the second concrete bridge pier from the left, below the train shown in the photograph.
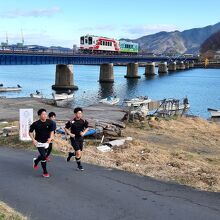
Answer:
[99,63,114,83]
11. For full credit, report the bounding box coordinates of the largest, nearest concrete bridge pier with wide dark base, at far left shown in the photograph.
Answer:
[52,64,78,92]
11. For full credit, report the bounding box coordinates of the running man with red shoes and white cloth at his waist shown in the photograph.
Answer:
[29,109,53,177]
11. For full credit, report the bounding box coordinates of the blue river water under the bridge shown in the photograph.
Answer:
[0,65,220,118]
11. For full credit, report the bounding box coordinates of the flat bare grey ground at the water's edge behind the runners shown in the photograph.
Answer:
[0,98,124,121]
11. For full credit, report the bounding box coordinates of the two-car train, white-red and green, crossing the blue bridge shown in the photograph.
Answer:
[79,35,139,54]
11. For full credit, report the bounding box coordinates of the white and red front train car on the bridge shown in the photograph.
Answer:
[80,35,120,53]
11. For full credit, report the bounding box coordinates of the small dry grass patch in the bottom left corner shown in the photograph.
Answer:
[0,202,28,220]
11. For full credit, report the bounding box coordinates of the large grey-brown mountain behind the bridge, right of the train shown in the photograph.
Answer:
[121,22,220,54]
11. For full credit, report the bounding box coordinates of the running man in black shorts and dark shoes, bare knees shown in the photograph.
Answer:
[65,107,89,171]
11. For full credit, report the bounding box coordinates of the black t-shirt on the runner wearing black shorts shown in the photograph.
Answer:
[65,118,88,138]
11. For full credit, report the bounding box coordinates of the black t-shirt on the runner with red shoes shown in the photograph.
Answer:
[29,119,54,143]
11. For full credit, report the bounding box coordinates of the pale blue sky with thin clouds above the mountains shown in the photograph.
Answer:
[0,0,220,48]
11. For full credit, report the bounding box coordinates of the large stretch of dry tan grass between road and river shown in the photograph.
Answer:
[52,117,220,191]
